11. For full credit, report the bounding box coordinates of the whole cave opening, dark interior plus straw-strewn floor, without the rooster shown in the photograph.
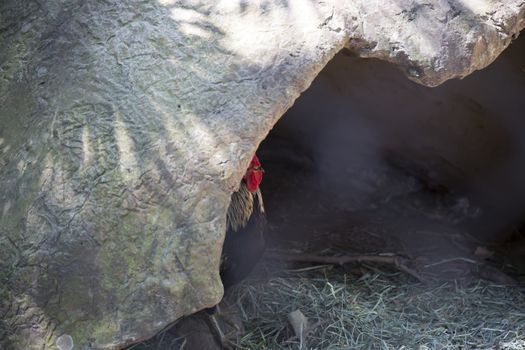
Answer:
[134,32,525,349]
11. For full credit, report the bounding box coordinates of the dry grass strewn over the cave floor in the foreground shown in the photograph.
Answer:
[231,266,525,350]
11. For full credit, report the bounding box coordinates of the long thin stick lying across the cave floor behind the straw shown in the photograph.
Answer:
[265,252,423,282]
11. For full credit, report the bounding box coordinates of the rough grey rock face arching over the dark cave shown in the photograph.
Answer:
[0,0,525,350]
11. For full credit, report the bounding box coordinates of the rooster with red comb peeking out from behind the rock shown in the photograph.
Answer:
[220,155,266,289]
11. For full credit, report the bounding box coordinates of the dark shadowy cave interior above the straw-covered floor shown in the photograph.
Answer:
[259,32,525,279]
